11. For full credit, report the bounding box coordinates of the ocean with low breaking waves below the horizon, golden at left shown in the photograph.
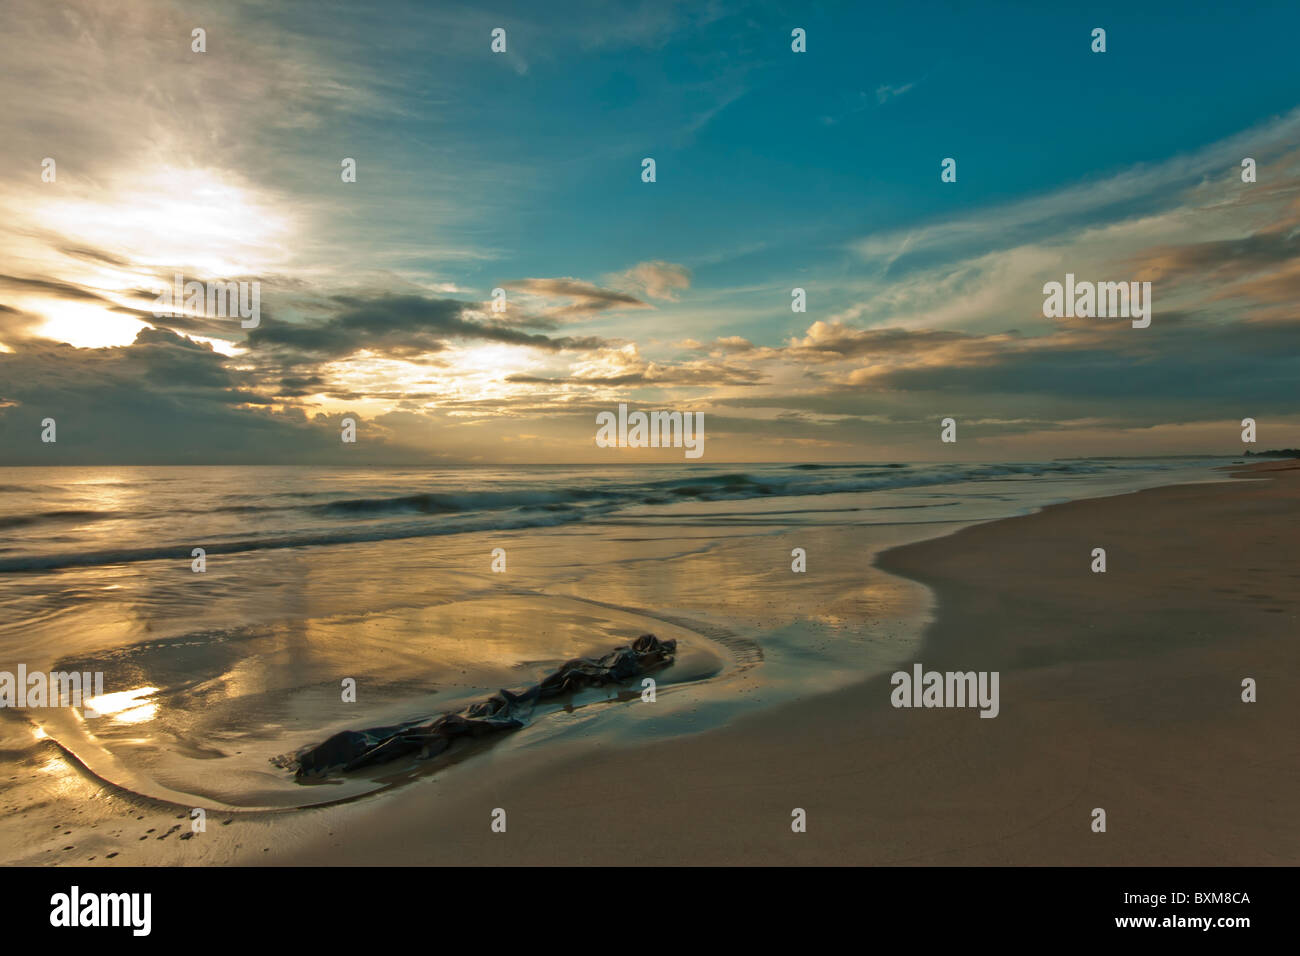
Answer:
[0,459,1227,572]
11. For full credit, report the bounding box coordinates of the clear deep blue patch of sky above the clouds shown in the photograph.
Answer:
[287,4,1300,306]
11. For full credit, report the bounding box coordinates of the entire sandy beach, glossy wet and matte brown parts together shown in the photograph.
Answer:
[3,462,1300,865]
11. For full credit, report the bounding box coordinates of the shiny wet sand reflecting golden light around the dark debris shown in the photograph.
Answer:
[0,489,946,866]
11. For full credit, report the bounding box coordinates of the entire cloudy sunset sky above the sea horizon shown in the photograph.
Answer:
[0,0,1300,464]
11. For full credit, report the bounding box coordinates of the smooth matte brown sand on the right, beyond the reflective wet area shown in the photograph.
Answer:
[263,462,1300,865]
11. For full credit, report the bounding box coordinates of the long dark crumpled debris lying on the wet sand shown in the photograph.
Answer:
[272,633,677,777]
